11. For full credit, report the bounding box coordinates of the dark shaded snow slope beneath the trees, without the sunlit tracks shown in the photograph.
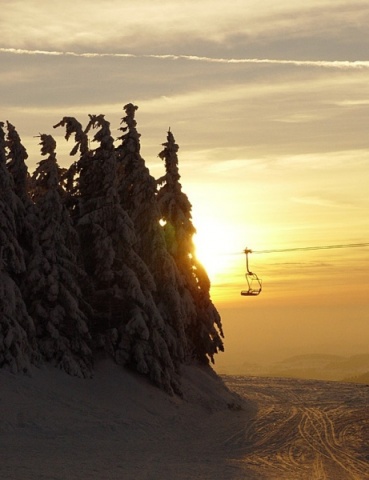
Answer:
[0,360,247,480]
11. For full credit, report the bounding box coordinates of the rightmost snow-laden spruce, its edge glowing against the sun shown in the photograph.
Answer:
[157,130,223,362]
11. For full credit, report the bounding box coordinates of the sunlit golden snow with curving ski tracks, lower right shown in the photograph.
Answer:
[226,377,369,480]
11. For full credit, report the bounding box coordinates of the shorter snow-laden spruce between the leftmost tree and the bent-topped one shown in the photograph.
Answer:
[27,134,92,377]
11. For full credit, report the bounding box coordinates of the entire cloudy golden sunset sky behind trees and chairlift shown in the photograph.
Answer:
[0,0,369,371]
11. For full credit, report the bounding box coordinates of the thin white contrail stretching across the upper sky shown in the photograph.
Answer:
[0,47,369,69]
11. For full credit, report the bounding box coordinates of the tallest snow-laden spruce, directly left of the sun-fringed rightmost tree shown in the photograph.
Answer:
[117,103,191,362]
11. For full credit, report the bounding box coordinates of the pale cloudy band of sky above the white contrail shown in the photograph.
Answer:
[0,0,369,61]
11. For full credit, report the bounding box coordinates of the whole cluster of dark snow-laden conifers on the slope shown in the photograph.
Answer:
[0,103,223,393]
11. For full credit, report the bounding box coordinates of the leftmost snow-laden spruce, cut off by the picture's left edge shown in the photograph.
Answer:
[0,122,37,372]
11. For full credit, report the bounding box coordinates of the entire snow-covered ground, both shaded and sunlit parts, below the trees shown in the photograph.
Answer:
[0,362,369,480]
